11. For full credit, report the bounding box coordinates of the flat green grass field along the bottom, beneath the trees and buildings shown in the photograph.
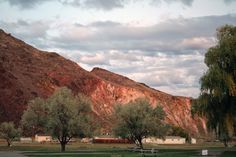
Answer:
[0,143,236,157]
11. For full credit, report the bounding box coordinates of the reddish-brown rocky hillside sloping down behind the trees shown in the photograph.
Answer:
[0,30,206,135]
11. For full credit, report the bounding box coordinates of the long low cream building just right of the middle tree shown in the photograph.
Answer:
[143,136,186,144]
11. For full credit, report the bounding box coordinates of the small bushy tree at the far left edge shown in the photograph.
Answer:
[0,122,20,147]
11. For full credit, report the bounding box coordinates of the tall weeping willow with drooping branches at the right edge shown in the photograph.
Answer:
[192,25,236,146]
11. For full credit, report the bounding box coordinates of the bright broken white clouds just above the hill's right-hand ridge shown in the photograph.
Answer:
[71,50,206,97]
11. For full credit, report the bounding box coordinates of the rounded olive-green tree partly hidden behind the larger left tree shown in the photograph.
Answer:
[21,98,49,137]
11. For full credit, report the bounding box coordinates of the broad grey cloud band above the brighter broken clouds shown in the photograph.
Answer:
[52,15,236,55]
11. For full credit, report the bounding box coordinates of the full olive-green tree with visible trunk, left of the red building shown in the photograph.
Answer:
[48,87,91,151]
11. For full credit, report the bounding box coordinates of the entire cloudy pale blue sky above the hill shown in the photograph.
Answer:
[0,0,236,98]
